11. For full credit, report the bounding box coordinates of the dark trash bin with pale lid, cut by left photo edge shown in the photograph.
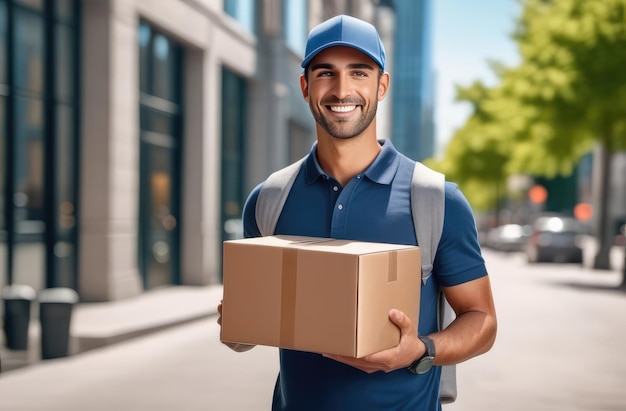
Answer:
[2,284,37,350]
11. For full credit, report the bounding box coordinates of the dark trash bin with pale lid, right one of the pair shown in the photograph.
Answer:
[39,287,78,360]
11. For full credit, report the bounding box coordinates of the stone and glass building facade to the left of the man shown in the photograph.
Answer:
[0,0,390,308]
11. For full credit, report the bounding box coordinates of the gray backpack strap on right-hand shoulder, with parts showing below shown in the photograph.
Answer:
[411,162,457,404]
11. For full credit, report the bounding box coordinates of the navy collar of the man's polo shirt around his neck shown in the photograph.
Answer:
[305,139,400,184]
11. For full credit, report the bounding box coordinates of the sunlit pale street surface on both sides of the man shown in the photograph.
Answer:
[0,250,626,411]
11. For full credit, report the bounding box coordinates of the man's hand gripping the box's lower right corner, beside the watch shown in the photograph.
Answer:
[325,309,426,374]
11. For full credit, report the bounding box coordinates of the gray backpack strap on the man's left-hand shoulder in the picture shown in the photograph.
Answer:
[254,157,306,236]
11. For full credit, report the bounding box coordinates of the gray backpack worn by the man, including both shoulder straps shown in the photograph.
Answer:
[255,157,457,404]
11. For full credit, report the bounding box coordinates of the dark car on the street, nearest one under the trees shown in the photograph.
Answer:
[526,216,587,263]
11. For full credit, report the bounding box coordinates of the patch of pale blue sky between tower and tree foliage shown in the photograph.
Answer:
[433,0,520,154]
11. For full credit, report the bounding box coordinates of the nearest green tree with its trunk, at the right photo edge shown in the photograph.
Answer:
[504,0,626,268]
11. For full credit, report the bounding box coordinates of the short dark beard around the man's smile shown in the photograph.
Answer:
[309,100,378,140]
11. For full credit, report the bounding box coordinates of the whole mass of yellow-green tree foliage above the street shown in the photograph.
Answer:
[429,0,626,212]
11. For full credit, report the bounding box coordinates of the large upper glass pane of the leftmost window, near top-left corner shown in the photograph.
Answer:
[15,9,44,94]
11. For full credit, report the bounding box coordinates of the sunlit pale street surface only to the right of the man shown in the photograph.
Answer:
[457,250,626,411]
